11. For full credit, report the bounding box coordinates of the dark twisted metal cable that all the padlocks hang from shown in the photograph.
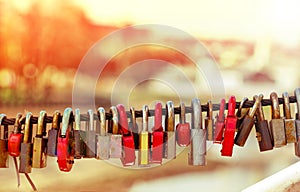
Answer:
[2,96,297,125]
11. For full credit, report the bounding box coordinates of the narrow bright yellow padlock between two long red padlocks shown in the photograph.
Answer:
[138,105,149,166]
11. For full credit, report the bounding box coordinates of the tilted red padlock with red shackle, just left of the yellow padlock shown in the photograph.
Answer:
[117,104,135,166]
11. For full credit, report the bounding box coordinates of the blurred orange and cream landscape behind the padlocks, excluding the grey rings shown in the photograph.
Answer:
[0,0,300,191]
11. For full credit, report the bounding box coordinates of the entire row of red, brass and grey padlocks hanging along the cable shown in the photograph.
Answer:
[0,88,300,174]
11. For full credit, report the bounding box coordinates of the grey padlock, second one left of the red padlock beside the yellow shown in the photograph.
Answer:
[96,107,110,160]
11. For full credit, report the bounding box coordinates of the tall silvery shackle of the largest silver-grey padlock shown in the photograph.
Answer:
[191,98,202,129]
